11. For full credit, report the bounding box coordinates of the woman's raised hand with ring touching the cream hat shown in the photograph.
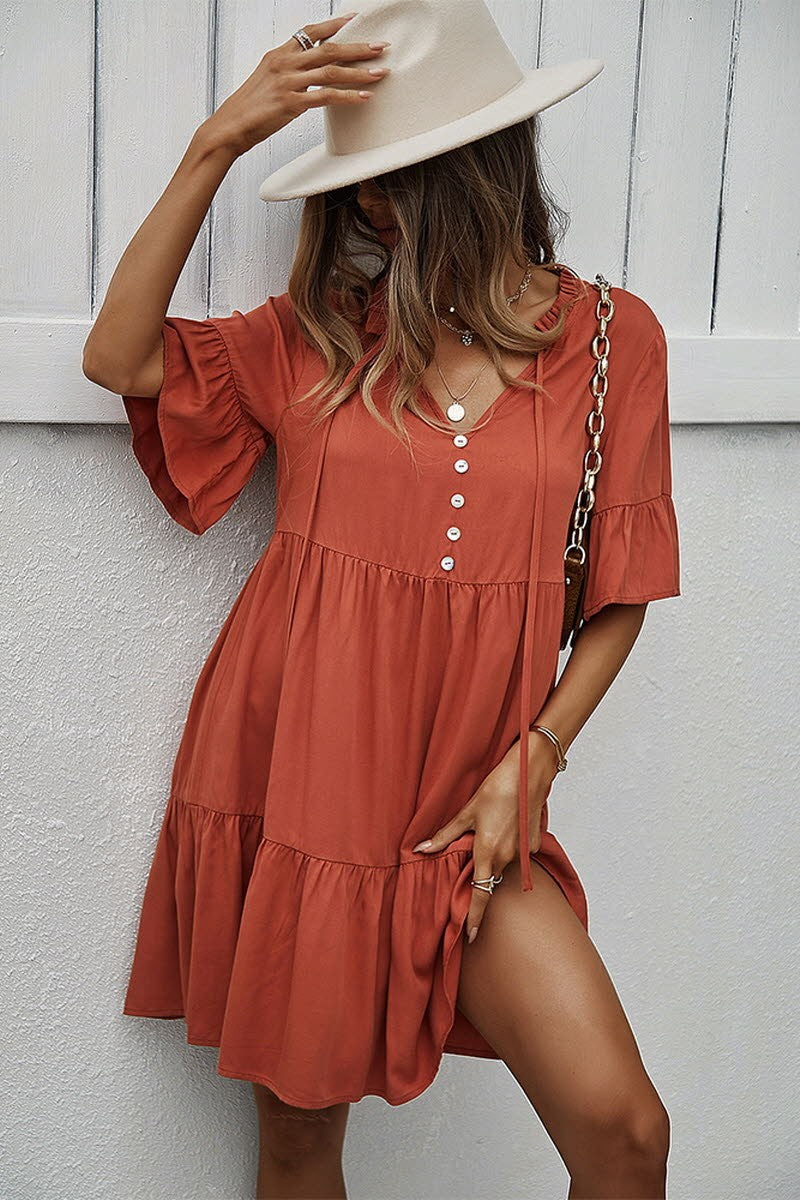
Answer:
[198,17,389,155]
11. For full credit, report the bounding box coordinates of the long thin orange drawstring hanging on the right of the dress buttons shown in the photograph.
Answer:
[518,350,546,892]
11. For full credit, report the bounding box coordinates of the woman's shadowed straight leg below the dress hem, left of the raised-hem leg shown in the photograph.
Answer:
[253,1084,350,1200]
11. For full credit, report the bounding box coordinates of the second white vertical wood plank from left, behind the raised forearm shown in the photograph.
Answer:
[96,0,215,317]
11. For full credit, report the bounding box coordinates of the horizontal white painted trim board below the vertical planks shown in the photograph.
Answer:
[0,318,800,425]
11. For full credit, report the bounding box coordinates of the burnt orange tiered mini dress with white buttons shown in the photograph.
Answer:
[122,266,680,1108]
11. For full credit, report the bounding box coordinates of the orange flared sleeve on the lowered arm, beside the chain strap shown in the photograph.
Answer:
[583,317,680,620]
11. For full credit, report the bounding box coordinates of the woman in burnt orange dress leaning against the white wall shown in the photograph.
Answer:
[84,9,679,1198]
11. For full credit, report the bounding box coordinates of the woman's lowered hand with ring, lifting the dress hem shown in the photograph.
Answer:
[414,730,558,942]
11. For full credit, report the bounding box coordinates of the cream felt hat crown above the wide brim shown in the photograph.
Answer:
[325,0,524,155]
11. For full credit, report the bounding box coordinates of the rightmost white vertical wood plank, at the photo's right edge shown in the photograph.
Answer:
[712,0,800,336]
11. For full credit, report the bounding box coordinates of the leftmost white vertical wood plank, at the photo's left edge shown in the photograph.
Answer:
[0,0,95,318]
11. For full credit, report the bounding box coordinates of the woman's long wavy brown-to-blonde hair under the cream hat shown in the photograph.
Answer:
[289,115,582,451]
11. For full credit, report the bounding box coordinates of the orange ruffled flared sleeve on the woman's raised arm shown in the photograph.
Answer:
[121,293,303,534]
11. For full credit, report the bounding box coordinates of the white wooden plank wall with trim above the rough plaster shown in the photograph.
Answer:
[0,0,800,422]
